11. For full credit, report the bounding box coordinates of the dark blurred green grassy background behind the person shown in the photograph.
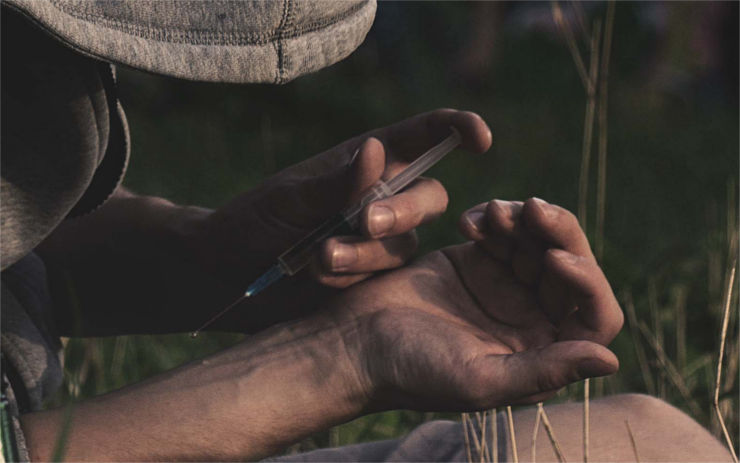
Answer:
[58,2,739,451]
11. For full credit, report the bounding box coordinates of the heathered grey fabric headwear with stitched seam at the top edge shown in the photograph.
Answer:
[4,0,375,83]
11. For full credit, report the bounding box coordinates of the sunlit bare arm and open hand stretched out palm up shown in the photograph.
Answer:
[22,200,622,460]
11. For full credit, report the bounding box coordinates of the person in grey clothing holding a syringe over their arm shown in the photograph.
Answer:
[2,1,725,461]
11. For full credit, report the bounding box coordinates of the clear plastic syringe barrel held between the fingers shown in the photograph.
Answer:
[278,180,393,275]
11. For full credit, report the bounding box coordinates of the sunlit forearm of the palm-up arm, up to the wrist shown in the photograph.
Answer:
[22,319,366,461]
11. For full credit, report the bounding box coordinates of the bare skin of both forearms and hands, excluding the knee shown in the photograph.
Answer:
[21,110,623,461]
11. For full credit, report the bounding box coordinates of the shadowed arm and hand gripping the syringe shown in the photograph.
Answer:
[37,109,491,336]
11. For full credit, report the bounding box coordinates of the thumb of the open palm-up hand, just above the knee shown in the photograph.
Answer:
[480,341,619,404]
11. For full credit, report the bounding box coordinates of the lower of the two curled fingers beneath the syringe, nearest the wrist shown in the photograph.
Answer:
[321,231,419,274]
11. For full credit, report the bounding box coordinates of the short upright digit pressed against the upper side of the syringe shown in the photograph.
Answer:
[296,137,385,220]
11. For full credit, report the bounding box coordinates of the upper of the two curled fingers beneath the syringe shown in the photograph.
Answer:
[360,178,449,239]
